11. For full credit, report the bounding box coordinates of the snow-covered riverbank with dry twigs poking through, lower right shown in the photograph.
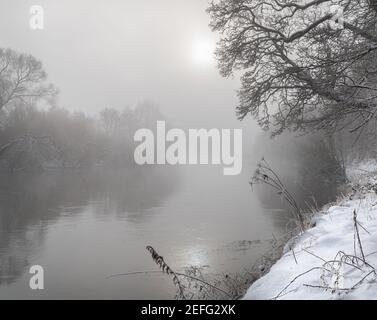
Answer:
[244,162,377,299]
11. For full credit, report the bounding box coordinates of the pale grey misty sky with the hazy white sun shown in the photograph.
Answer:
[0,0,256,134]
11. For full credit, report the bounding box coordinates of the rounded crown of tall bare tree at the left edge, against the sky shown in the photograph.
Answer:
[0,49,56,111]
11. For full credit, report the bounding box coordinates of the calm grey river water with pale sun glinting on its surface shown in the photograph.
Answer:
[0,166,290,299]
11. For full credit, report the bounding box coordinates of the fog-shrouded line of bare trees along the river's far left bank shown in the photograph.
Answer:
[0,49,163,172]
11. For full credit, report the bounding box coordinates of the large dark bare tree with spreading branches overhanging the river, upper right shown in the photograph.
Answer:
[208,0,377,134]
